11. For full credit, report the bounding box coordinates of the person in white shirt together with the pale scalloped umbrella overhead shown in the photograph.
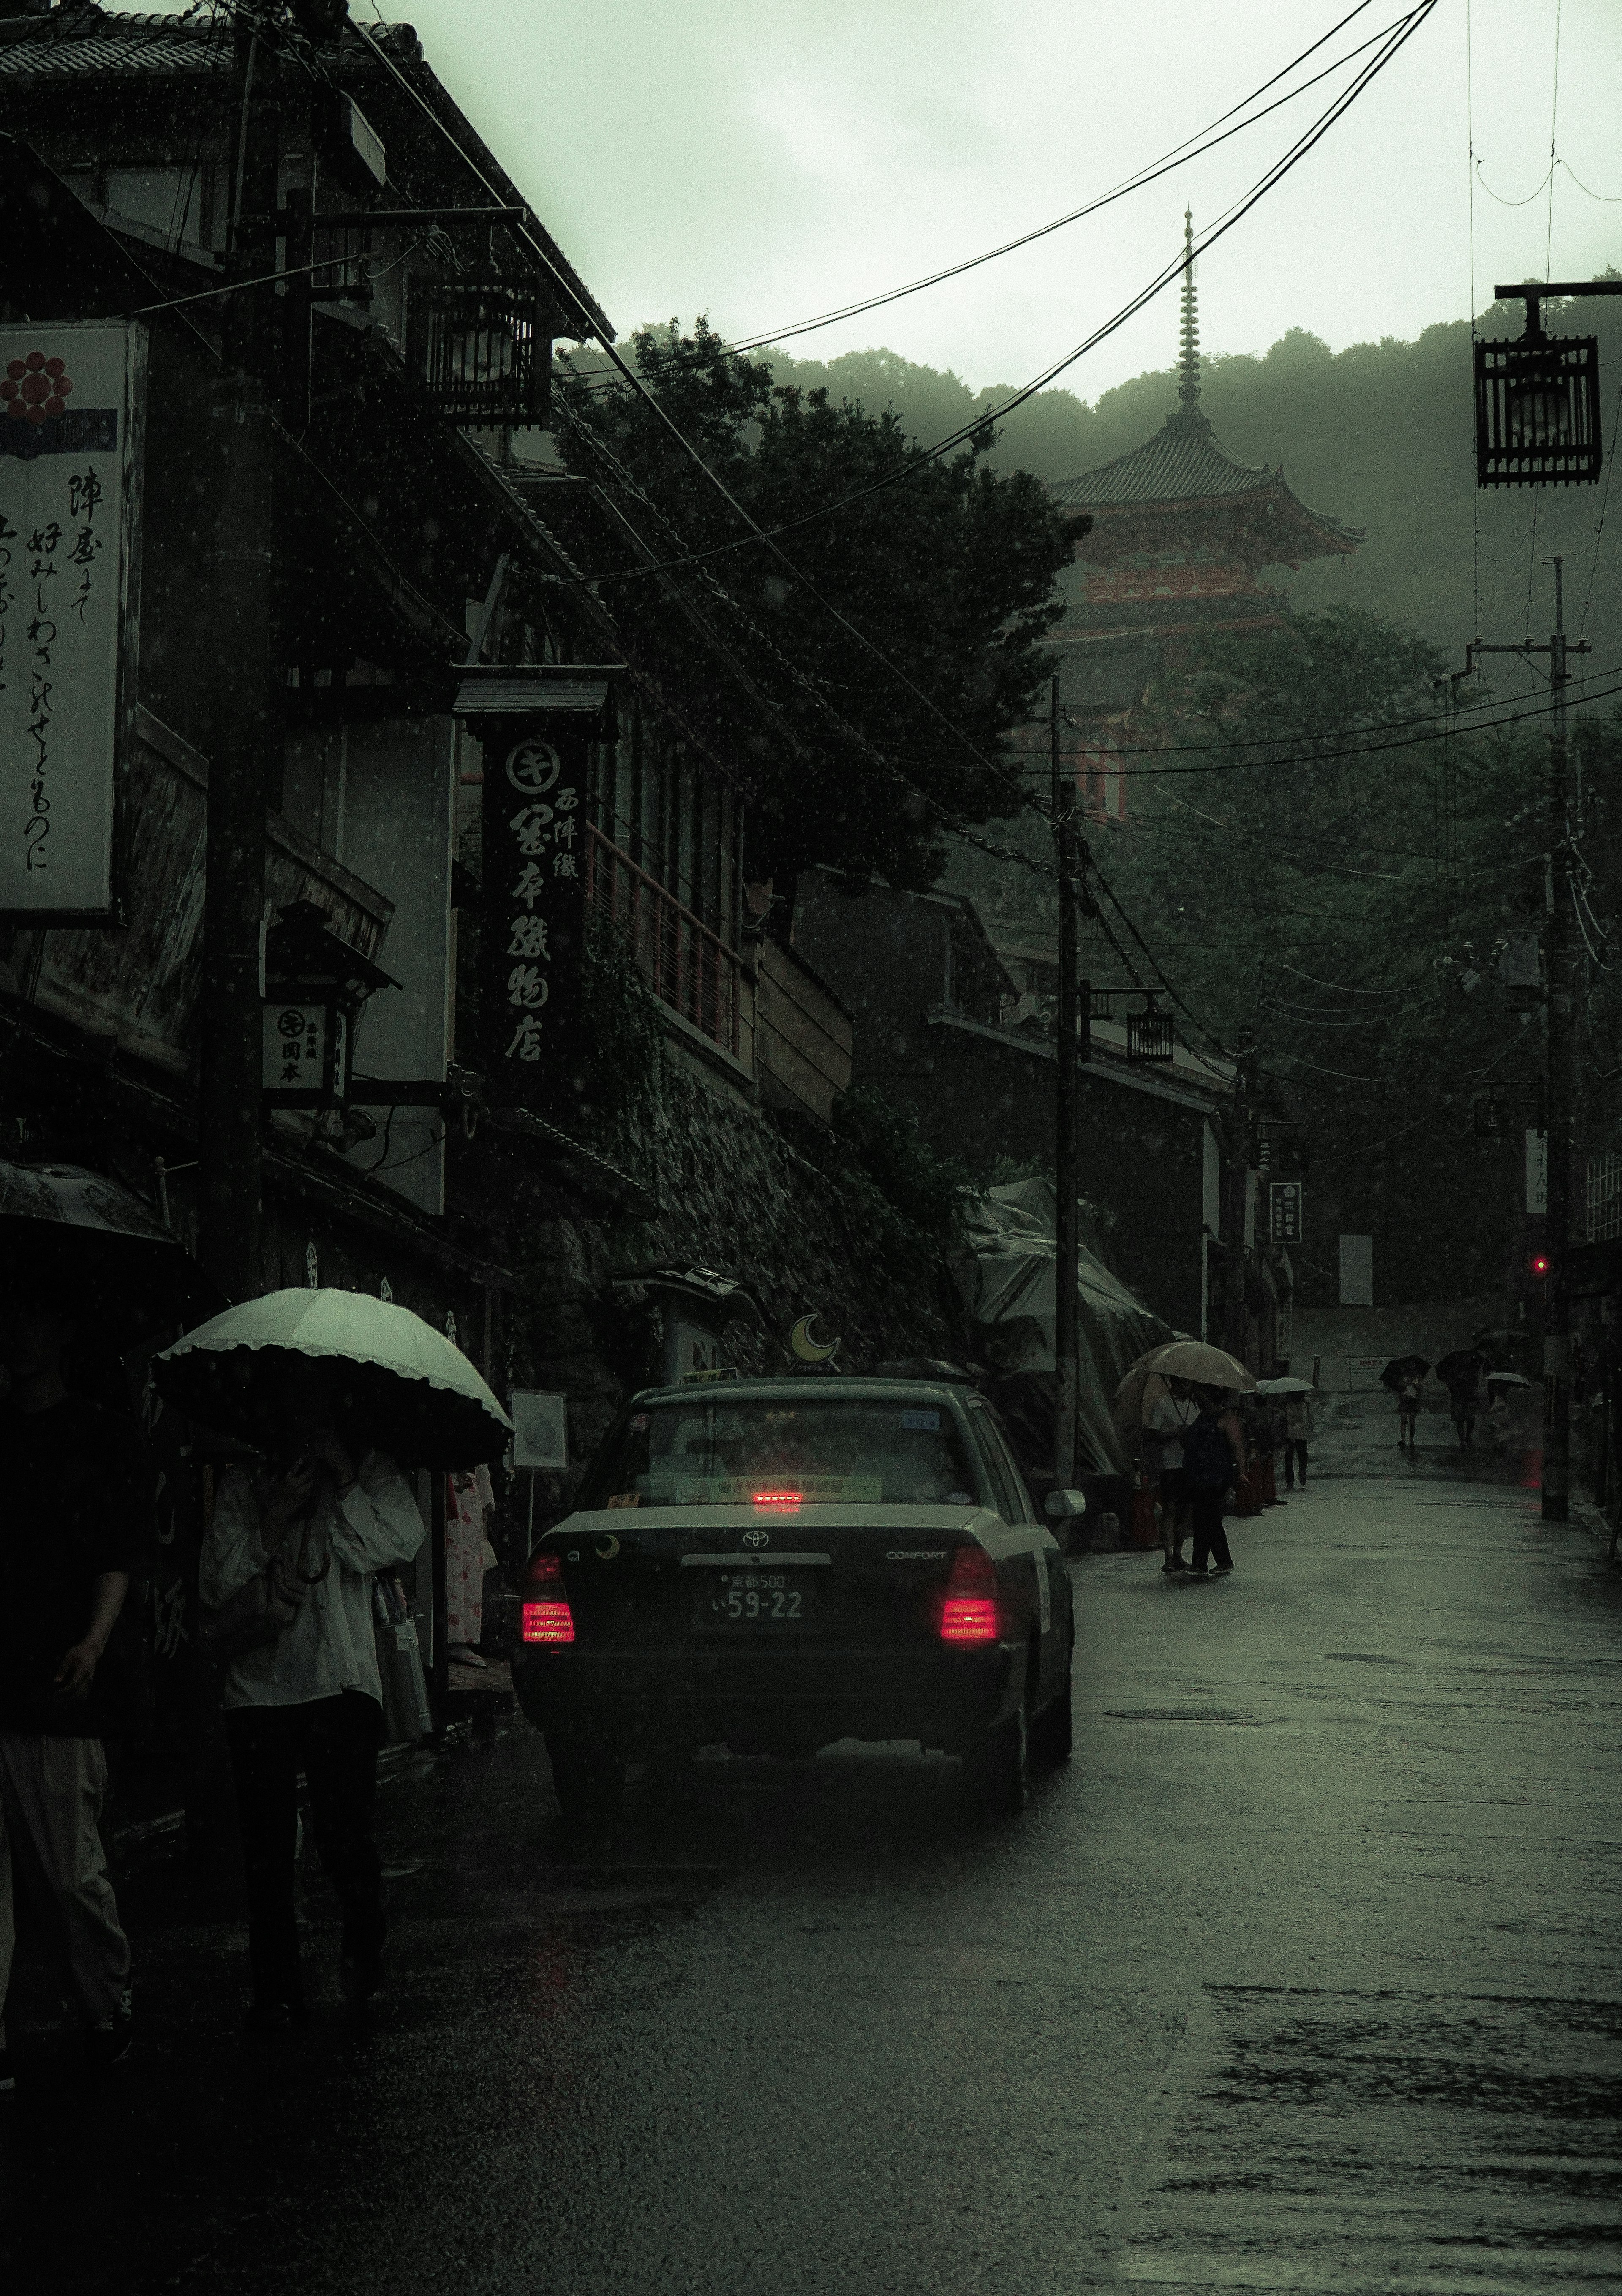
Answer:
[165,1290,512,2032]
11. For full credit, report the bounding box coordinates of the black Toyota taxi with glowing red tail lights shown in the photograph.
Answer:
[512,1375,1083,1819]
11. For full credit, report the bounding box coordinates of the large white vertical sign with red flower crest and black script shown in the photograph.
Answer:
[0,324,144,923]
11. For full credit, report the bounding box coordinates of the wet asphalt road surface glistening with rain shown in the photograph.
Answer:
[0,1426,1622,2296]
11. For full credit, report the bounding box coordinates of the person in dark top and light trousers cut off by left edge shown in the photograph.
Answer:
[0,1274,154,2089]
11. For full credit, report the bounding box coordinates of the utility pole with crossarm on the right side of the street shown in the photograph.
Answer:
[1464,562,1592,1522]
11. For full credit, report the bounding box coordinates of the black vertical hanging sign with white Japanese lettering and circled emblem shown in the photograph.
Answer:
[470,709,592,1111]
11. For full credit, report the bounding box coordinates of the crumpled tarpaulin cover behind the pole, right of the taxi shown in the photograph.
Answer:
[959,1180,1175,1474]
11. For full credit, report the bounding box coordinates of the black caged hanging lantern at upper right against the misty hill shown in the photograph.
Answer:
[1475,280,1622,487]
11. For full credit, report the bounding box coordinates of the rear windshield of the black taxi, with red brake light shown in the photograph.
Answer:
[578,1396,980,1508]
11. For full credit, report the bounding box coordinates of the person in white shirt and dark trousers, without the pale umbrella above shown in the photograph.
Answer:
[202,1357,422,2032]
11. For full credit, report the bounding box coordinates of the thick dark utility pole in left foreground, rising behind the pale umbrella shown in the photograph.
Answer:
[197,21,282,1300]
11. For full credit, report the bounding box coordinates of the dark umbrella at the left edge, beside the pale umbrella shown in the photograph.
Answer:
[0,1162,225,1355]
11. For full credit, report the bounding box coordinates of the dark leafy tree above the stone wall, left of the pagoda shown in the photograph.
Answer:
[555,322,1069,886]
